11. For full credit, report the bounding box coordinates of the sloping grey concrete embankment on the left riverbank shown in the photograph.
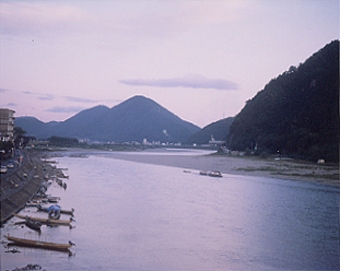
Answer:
[0,150,52,225]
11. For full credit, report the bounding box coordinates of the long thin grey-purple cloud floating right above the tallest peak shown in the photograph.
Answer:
[119,74,238,90]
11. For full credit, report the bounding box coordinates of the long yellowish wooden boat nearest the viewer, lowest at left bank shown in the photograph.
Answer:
[4,234,73,251]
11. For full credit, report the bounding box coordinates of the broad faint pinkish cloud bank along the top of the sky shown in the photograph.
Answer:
[0,0,250,41]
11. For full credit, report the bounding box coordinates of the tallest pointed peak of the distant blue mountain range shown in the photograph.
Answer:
[87,96,200,142]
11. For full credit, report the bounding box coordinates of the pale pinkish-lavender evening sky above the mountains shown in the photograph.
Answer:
[0,0,339,128]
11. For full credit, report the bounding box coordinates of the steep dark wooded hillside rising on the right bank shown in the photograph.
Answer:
[227,40,339,161]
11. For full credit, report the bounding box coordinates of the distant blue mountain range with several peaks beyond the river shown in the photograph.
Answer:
[15,96,200,143]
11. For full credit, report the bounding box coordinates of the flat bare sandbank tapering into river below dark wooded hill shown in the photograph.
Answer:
[109,153,340,187]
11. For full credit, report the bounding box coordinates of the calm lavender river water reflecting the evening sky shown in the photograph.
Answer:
[1,152,340,270]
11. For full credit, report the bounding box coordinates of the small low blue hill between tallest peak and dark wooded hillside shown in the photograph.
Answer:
[188,117,234,144]
